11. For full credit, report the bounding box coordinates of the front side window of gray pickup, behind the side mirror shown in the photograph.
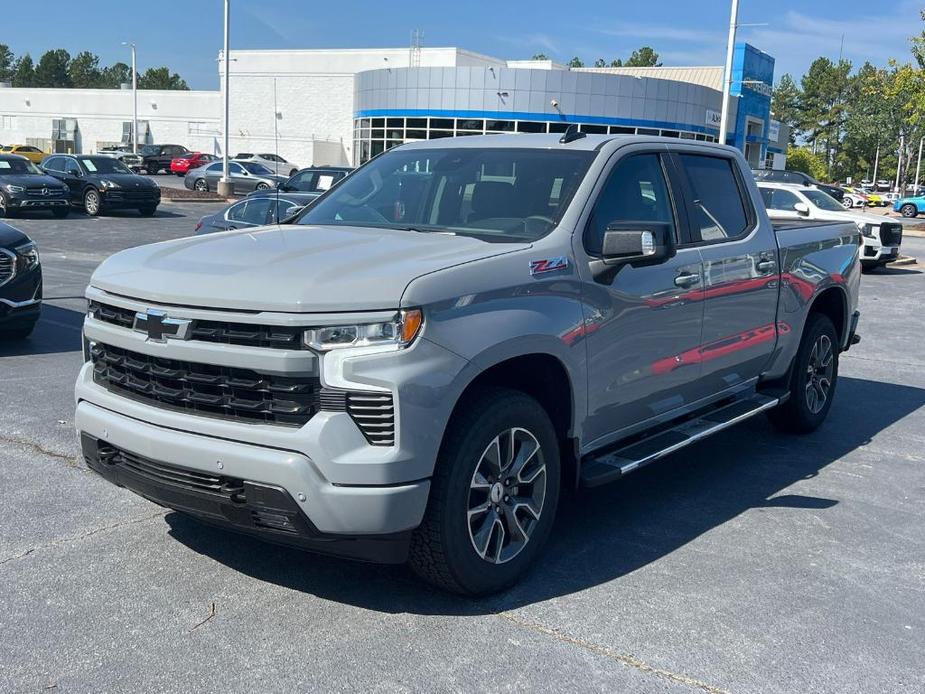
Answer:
[584,154,675,256]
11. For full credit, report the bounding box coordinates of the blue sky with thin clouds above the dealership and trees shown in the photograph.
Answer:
[0,0,925,89]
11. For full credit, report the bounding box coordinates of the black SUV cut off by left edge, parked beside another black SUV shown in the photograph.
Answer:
[0,154,70,217]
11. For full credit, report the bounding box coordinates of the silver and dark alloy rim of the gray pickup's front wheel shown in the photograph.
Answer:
[467,427,546,564]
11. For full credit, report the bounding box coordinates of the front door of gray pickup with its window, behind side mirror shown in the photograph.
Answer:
[575,151,706,448]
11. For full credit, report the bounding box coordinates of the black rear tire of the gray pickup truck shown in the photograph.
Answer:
[768,313,840,434]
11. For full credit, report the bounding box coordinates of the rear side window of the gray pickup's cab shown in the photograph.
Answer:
[679,154,749,242]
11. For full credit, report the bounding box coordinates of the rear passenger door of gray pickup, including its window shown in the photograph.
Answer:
[674,149,785,393]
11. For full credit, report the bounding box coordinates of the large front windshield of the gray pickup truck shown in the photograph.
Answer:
[298,147,595,242]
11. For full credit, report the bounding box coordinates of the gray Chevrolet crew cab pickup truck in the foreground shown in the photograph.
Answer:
[76,135,860,594]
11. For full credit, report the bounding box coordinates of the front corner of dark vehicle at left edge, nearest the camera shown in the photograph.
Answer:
[0,222,42,339]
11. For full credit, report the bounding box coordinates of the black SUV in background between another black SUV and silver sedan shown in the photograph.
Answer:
[42,154,161,217]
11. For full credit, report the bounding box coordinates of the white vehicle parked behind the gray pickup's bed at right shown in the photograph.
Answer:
[758,183,903,269]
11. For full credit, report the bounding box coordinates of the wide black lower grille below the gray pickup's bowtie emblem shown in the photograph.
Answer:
[90,343,321,426]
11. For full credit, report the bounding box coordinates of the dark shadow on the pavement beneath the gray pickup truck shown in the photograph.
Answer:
[166,377,925,615]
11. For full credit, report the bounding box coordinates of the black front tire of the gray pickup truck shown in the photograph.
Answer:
[409,388,560,595]
